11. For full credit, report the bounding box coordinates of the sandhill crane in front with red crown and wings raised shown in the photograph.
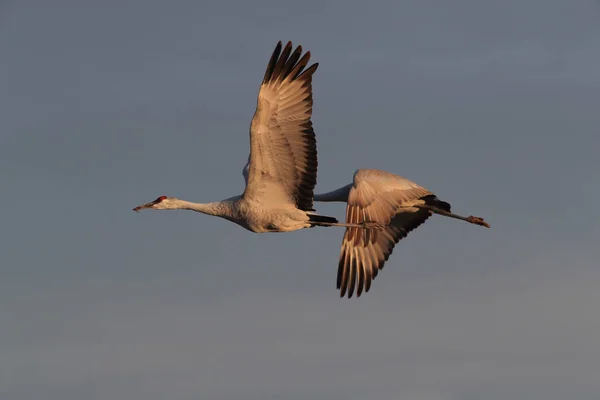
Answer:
[133,42,377,233]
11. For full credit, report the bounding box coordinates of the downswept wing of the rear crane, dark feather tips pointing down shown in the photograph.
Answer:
[337,170,434,298]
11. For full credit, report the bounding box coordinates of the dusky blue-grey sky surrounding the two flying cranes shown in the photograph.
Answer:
[0,0,600,400]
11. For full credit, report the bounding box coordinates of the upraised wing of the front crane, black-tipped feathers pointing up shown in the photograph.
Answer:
[244,42,318,211]
